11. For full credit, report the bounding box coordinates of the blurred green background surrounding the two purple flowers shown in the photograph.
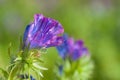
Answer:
[0,0,120,80]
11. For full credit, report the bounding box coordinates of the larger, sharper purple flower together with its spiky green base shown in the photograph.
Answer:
[1,14,64,80]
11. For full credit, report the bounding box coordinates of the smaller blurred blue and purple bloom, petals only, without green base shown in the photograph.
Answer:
[57,34,88,60]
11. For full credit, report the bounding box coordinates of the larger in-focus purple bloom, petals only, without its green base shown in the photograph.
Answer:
[23,14,64,48]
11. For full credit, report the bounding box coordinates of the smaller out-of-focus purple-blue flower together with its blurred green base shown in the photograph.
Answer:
[55,34,93,80]
